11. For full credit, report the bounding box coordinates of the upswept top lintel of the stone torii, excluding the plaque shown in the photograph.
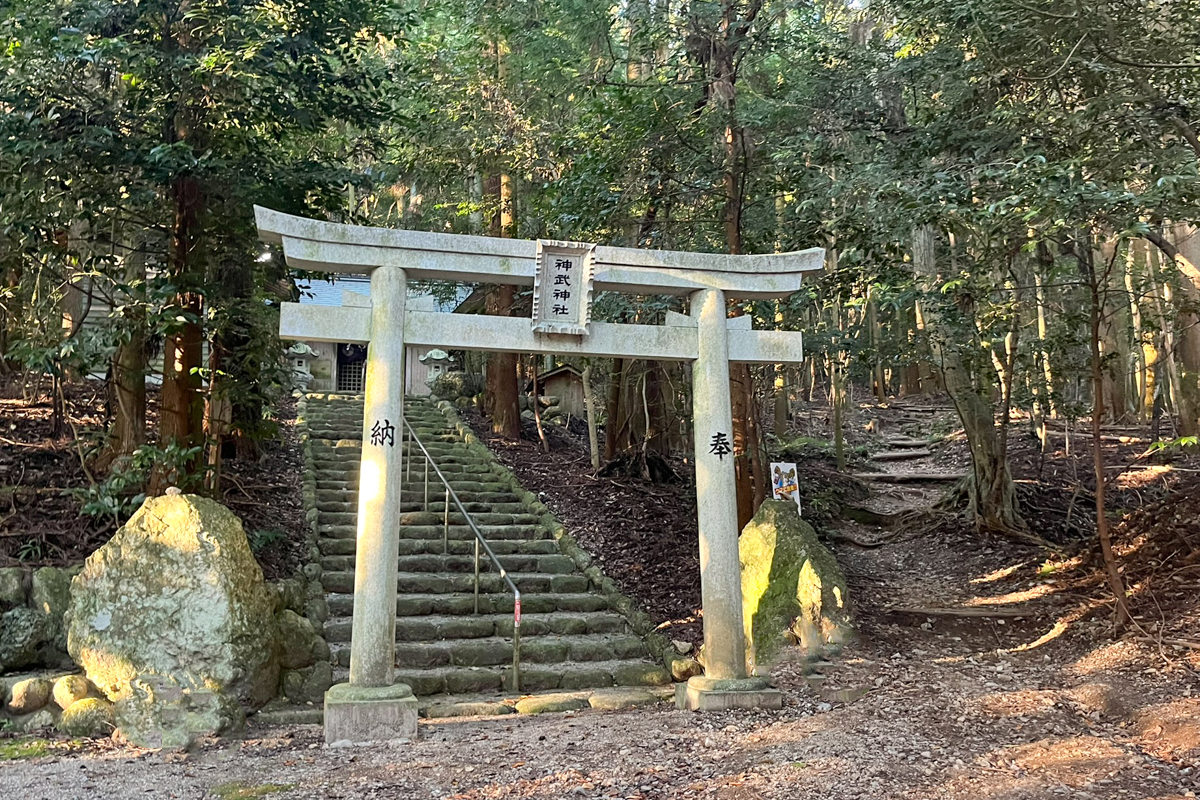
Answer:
[254,206,824,300]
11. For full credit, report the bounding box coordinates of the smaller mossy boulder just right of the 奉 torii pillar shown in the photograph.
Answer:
[738,500,853,666]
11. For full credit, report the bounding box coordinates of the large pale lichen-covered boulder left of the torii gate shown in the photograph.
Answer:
[66,494,280,746]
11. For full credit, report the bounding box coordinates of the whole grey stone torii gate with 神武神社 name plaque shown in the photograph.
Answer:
[254,207,824,741]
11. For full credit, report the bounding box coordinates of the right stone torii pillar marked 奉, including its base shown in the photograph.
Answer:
[677,289,784,711]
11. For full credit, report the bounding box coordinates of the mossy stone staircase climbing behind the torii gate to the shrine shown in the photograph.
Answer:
[302,395,671,705]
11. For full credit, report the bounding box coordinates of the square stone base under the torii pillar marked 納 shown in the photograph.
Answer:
[325,684,416,745]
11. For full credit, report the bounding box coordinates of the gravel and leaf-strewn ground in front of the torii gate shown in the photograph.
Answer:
[0,642,1200,800]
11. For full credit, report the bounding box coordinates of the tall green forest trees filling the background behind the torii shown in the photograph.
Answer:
[0,0,1200,575]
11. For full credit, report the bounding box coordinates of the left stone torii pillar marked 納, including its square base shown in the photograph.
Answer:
[325,265,416,744]
